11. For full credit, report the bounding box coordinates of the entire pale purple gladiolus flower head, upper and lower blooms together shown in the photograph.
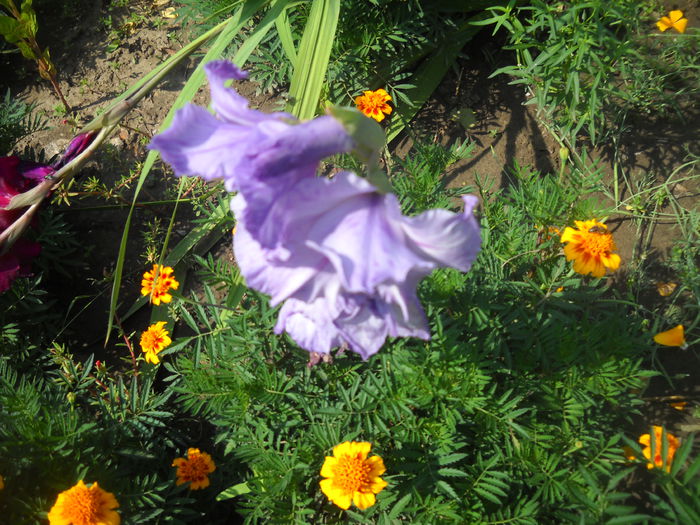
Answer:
[150,61,481,359]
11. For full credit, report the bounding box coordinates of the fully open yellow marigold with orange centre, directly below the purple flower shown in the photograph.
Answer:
[321,441,387,510]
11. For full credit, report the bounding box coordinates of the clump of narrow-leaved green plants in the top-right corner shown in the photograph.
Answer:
[488,0,698,144]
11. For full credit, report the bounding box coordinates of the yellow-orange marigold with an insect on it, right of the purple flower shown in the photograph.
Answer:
[561,219,620,277]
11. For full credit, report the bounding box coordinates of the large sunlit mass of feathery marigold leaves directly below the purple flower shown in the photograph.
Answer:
[163,151,692,524]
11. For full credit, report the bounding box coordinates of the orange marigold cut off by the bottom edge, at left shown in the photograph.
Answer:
[49,479,121,525]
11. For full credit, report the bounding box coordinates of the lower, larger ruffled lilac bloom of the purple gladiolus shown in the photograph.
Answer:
[232,172,481,359]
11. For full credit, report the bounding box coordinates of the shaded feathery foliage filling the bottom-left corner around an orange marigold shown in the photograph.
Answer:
[0,323,211,525]
